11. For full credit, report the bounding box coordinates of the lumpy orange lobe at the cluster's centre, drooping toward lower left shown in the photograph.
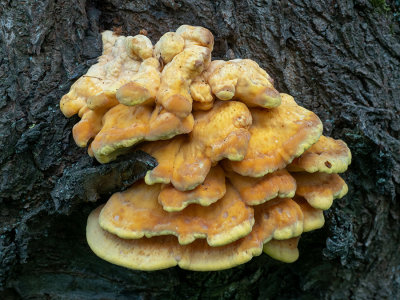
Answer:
[142,101,252,191]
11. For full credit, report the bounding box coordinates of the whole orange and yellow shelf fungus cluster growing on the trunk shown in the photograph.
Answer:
[60,25,351,271]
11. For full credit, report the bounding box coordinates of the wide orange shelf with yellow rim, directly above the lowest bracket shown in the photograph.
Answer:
[99,182,254,246]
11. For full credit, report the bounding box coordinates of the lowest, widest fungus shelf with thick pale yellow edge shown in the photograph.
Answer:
[86,195,303,271]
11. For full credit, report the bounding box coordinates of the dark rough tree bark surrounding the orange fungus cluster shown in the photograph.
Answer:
[0,0,400,299]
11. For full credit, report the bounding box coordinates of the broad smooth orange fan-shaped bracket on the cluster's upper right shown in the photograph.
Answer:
[224,94,322,177]
